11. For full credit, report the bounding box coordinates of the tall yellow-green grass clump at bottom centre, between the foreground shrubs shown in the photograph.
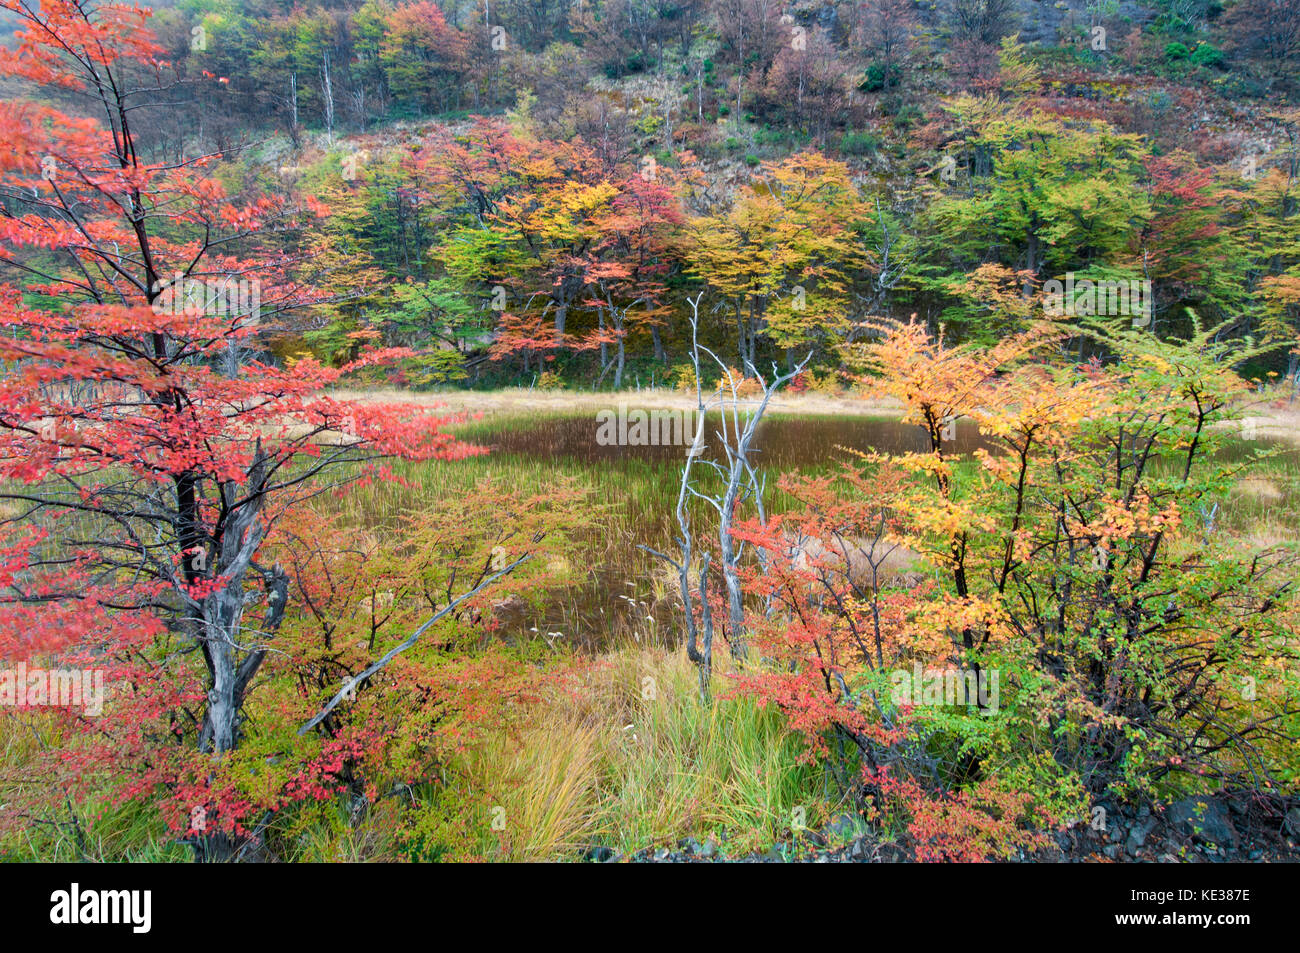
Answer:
[449,645,822,861]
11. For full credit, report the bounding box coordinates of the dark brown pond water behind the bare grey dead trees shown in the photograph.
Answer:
[444,411,1300,650]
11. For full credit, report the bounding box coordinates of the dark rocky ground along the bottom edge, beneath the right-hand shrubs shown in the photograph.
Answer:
[584,796,1300,863]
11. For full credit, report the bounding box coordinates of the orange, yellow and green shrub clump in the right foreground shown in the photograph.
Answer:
[712,317,1297,859]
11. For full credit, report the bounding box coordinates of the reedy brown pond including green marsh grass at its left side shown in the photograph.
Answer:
[334,410,946,651]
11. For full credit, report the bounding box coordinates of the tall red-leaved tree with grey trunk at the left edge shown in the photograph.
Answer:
[0,0,477,857]
